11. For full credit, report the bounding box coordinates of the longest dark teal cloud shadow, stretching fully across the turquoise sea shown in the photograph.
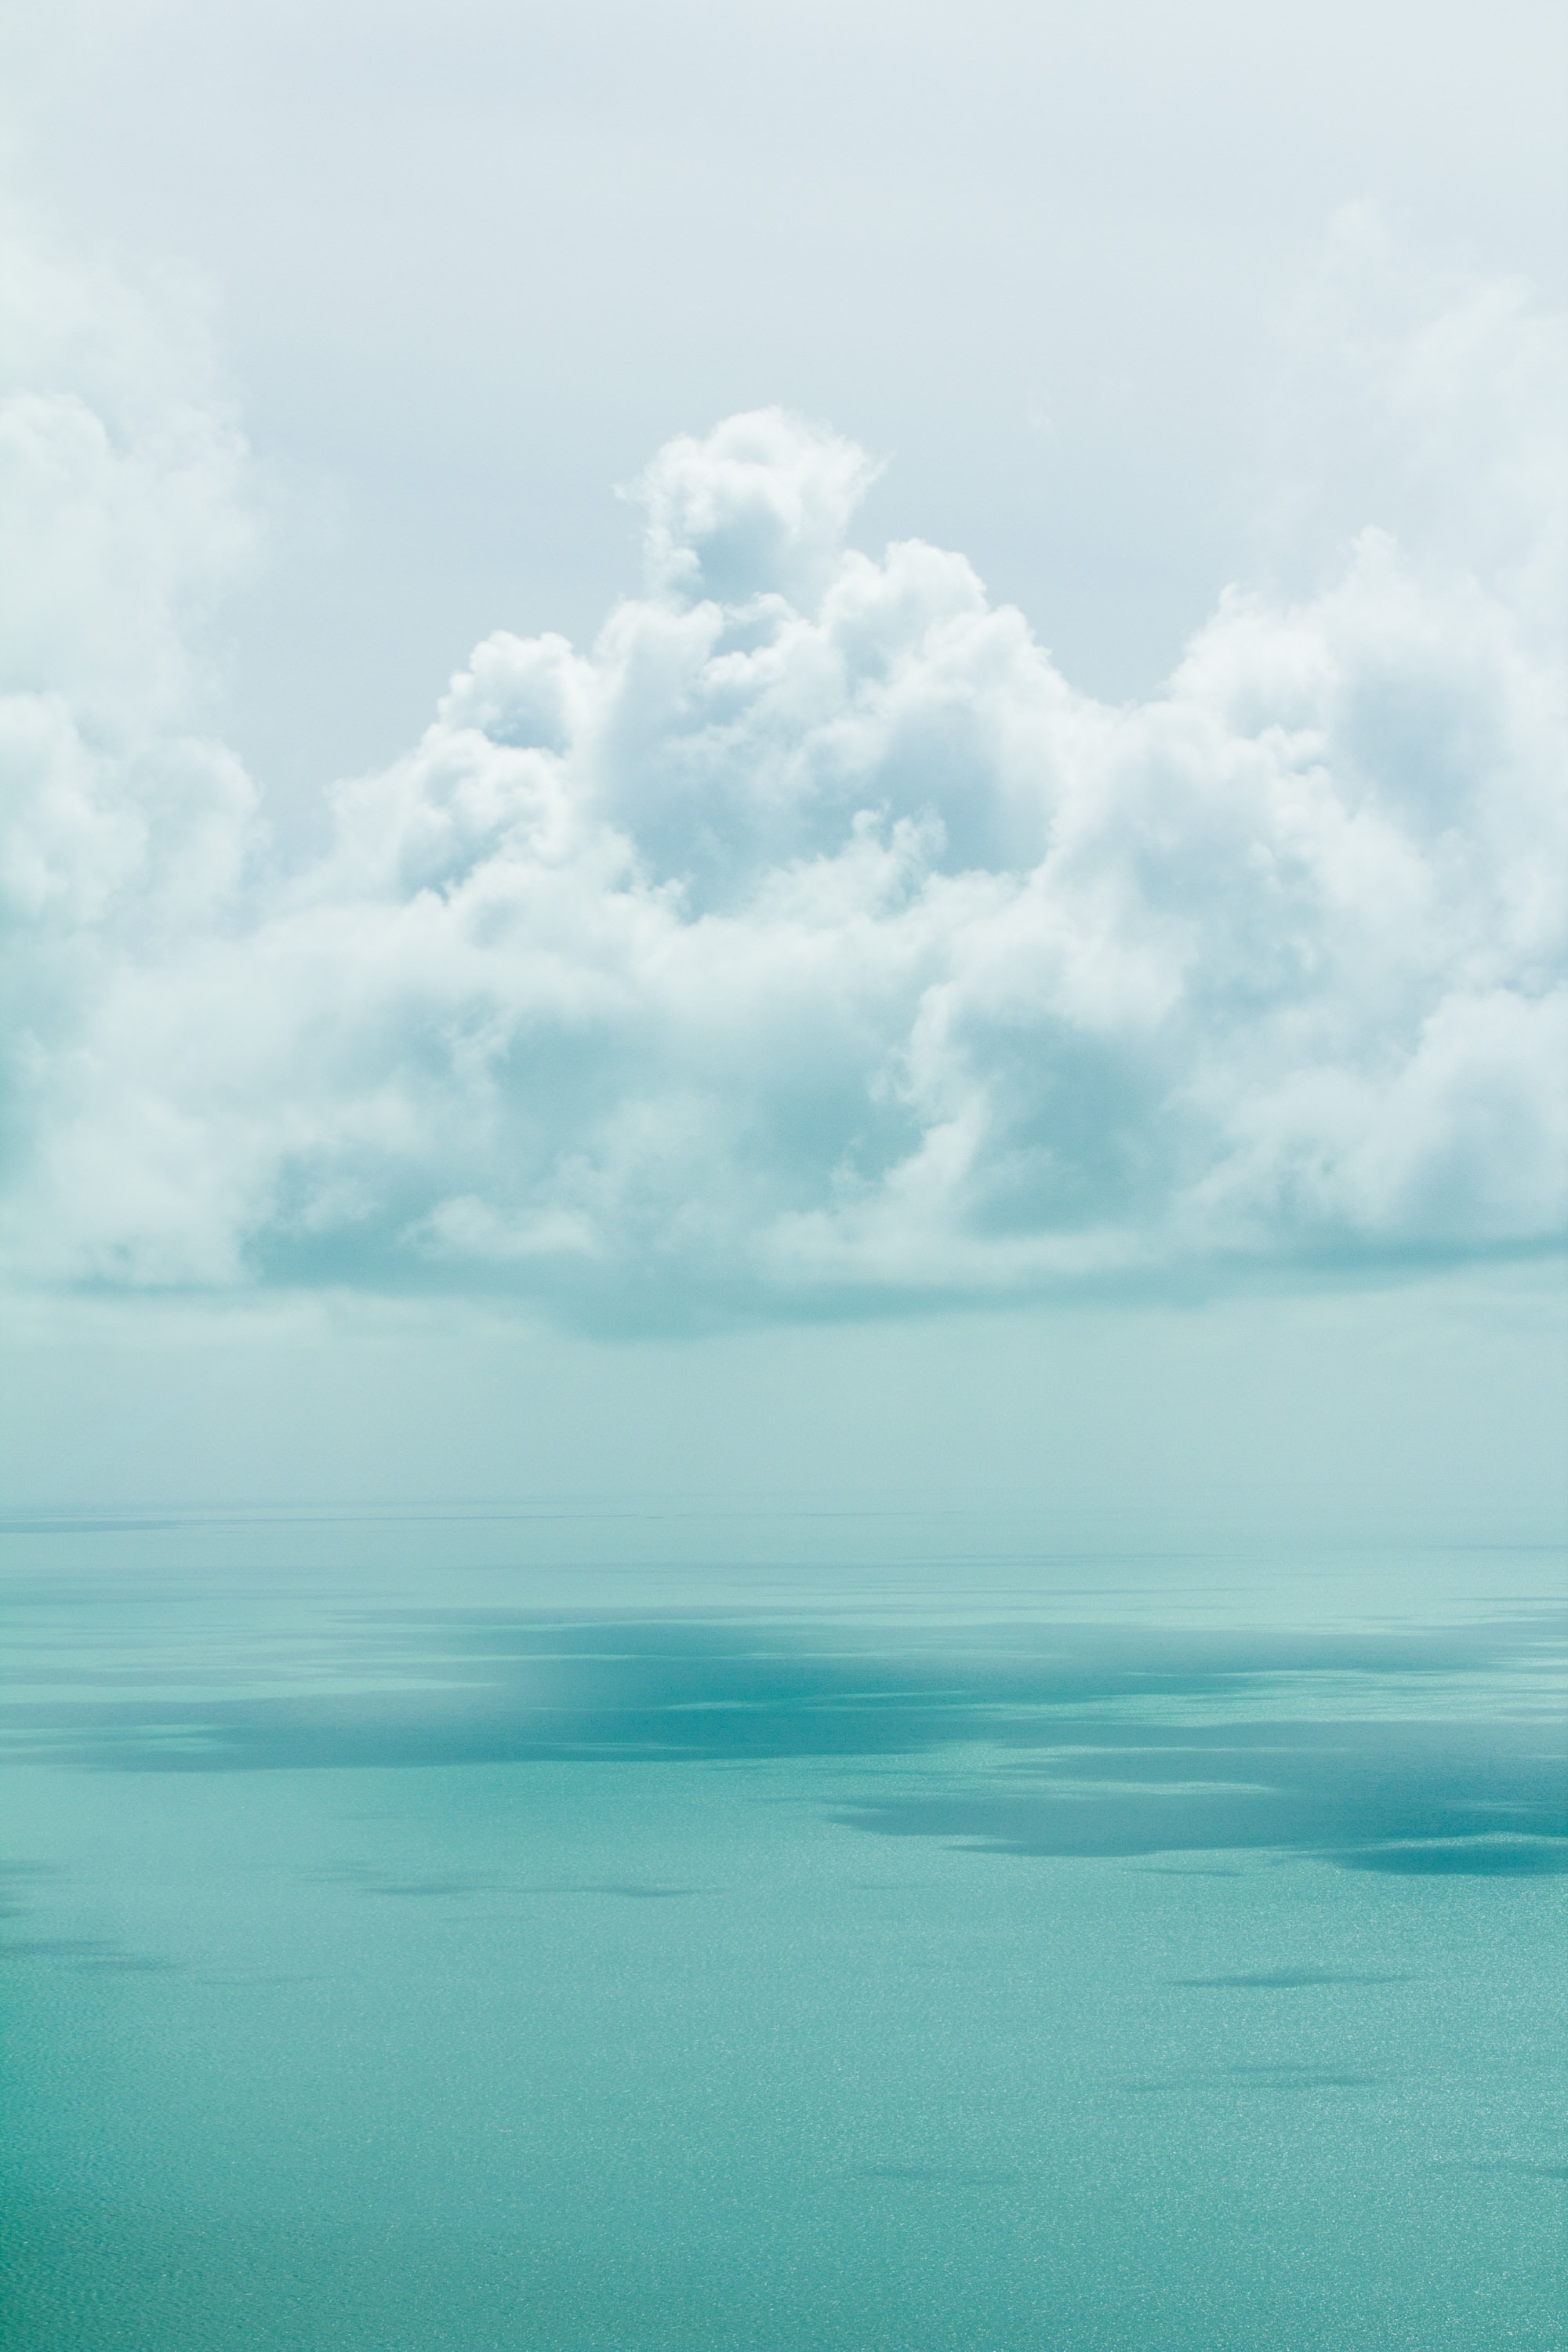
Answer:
[12,1611,1547,1778]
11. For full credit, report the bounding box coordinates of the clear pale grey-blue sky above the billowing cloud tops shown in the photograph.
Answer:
[7,0,1568,818]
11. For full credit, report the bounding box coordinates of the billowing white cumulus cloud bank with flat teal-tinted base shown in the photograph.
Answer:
[0,221,1568,1322]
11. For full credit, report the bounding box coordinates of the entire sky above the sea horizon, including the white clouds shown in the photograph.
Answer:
[0,0,1568,1541]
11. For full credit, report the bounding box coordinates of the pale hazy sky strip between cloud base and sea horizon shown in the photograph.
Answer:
[5,1270,1568,1562]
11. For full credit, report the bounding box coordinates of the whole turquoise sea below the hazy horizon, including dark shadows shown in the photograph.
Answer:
[5,1510,1568,2352]
